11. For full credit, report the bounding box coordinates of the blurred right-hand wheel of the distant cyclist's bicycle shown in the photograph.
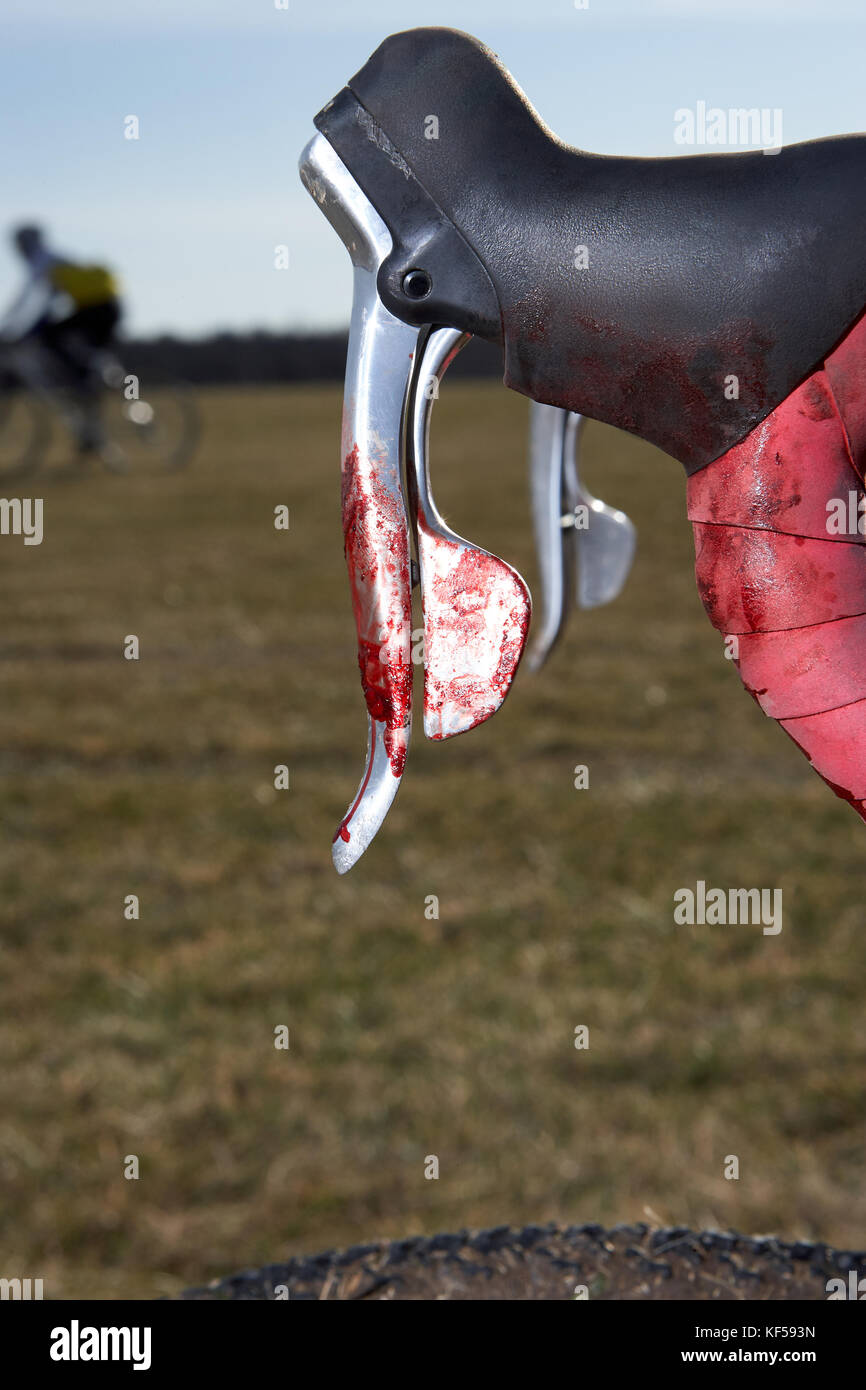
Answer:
[103,382,202,473]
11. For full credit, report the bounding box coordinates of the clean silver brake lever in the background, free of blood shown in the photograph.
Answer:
[527,400,637,671]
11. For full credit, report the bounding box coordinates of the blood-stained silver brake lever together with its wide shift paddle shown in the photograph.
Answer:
[300,135,530,873]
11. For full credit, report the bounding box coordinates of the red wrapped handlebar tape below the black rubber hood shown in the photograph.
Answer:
[688,309,866,819]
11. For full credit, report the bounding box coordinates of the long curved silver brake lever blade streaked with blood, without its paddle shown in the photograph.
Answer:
[300,135,418,873]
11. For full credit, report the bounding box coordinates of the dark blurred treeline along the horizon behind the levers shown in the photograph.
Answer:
[122,332,503,385]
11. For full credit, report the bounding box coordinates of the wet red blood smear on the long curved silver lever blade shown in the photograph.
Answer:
[342,445,411,778]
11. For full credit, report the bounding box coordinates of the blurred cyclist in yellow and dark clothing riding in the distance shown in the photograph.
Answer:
[0,227,122,455]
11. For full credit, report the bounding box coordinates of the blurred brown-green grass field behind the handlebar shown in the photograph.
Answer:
[0,382,866,1298]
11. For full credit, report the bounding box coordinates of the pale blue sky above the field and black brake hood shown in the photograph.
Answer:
[0,0,866,335]
